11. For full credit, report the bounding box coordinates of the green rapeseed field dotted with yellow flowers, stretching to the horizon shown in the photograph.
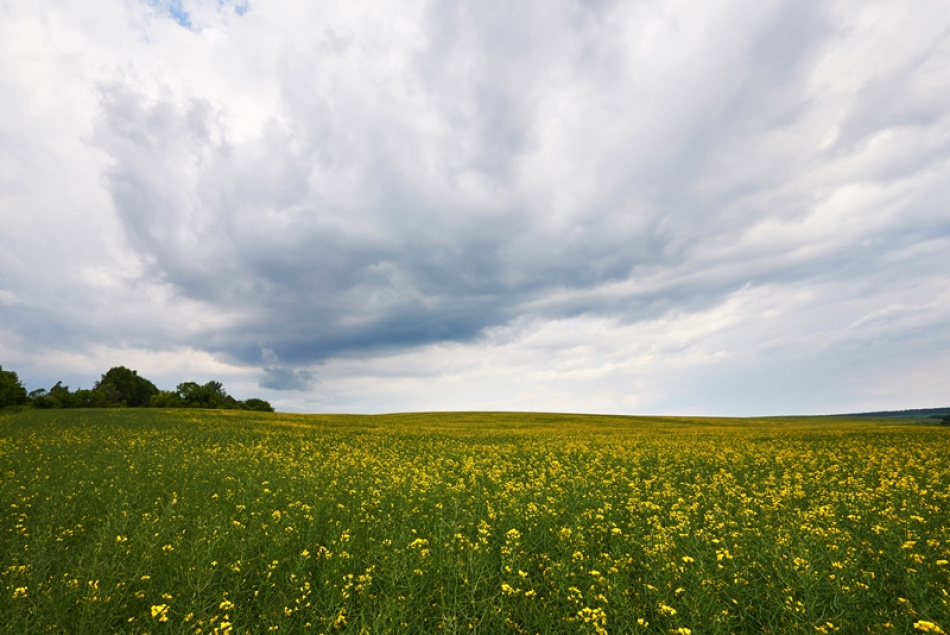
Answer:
[0,410,950,635]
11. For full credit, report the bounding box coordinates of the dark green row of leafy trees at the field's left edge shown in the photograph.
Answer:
[0,366,274,412]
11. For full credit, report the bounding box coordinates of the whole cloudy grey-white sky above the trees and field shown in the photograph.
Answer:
[0,0,950,416]
